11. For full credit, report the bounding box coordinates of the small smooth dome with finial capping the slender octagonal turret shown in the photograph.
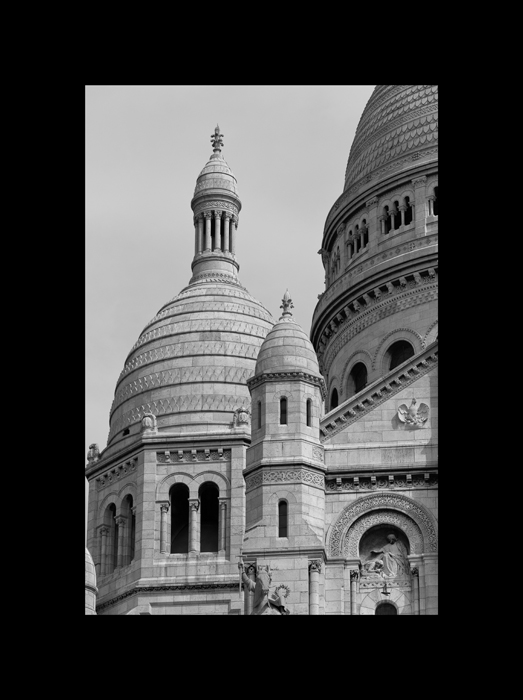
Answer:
[254,291,321,377]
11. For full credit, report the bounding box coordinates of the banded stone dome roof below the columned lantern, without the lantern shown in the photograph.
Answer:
[108,280,274,444]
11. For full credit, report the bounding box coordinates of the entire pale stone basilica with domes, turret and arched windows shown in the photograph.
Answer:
[85,85,439,615]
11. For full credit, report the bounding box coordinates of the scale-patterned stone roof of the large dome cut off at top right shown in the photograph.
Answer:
[344,85,438,192]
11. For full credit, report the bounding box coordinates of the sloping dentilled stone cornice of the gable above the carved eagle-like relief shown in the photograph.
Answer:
[320,341,438,443]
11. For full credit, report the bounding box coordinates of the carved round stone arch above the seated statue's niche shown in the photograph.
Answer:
[327,493,438,557]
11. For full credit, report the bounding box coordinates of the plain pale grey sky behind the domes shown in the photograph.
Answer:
[85,85,375,454]
